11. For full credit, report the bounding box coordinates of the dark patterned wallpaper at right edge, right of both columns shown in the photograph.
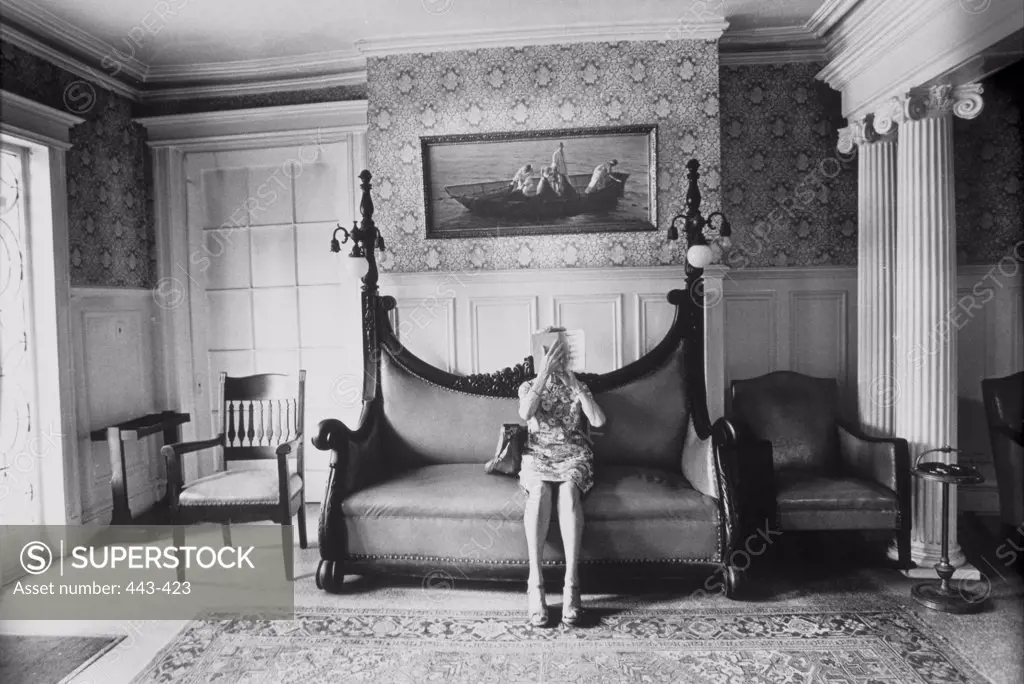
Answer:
[953,61,1024,263]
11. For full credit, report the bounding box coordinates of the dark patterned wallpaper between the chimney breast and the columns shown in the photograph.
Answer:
[720,63,857,267]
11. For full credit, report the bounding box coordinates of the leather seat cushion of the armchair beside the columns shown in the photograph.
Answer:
[775,470,899,530]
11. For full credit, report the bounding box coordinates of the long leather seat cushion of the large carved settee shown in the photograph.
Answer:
[342,464,720,563]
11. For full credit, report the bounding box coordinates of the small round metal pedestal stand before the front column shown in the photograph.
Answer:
[910,446,987,613]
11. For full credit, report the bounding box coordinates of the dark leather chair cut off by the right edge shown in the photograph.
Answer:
[981,371,1024,536]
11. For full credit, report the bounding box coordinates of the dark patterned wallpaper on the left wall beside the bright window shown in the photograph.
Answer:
[0,43,155,288]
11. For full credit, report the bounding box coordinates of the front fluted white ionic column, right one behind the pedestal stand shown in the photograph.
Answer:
[874,85,981,569]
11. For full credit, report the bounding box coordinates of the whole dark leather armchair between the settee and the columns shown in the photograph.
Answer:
[729,371,910,567]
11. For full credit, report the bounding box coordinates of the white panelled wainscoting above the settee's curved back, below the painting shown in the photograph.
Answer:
[380,266,685,374]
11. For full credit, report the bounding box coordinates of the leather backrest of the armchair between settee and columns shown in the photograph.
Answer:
[732,372,839,473]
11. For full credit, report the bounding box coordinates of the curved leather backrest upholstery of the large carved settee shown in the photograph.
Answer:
[381,339,689,472]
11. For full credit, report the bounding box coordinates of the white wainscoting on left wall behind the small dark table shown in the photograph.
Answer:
[71,288,166,523]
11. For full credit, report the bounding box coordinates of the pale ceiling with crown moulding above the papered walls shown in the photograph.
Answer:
[0,0,839,96]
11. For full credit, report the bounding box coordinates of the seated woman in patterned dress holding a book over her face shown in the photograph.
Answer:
[519,328,604,627]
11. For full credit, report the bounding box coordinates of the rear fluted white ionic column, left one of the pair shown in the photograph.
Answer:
[838,116,897,436]
